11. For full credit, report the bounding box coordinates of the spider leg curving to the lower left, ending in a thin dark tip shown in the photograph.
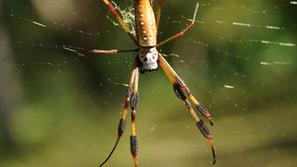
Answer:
[99,67,138,167]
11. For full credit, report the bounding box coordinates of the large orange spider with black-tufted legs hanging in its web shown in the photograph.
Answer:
[65,0,216,167]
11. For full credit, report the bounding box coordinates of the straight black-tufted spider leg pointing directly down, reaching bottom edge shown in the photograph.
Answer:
[130,68,139,167]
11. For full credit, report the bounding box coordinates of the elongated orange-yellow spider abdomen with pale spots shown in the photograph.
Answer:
[135,0,157,47]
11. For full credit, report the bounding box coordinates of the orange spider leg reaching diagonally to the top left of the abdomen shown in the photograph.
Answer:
[103,0,138,45]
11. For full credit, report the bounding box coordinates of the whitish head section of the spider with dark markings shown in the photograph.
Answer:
[138,47,159,73]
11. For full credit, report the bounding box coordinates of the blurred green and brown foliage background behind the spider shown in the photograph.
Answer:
[0,0,297,167]
